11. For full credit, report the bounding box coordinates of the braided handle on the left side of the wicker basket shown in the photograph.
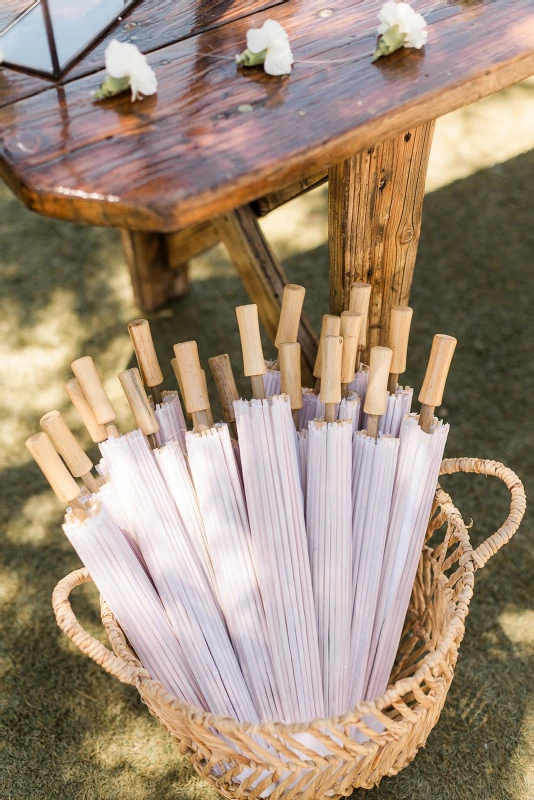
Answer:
[52,569,144,686]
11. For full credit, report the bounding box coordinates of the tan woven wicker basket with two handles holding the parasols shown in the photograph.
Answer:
[53,459,526,800]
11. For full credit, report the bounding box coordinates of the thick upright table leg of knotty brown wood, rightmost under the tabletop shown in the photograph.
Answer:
[328,122,434,360]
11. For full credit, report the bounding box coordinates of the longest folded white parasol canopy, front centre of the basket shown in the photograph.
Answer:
[234,395,324,722]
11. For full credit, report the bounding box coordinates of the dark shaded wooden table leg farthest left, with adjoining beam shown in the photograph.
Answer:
[121,222,219,311]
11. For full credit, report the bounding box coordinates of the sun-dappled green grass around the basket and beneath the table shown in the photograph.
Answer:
[0,83,534,800]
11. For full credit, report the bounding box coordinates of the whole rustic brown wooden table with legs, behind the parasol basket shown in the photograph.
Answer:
[0,0,534,376]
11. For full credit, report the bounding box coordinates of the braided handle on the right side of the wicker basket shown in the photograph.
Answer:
[440,458,527,568]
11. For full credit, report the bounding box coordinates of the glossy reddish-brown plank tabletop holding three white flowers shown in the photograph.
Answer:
[0,0,534,232]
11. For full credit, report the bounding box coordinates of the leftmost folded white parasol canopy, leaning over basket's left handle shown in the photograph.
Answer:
[63,501,205,710]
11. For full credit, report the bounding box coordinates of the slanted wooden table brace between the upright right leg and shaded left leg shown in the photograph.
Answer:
[214,206,317,386]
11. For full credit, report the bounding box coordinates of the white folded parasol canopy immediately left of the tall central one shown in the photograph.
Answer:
[186,424,283,722]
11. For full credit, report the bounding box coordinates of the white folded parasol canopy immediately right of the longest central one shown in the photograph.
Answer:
[306,420,352,716]
